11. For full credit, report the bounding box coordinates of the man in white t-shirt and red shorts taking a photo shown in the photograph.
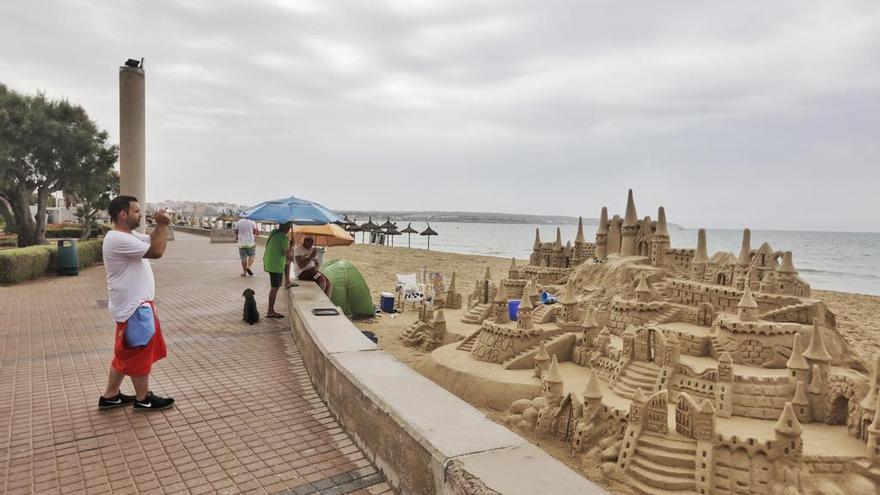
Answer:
[98,196,174,411]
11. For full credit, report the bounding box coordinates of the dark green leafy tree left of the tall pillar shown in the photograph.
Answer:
[0,84,117,246]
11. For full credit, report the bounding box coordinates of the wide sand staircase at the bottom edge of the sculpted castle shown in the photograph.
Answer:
[626,432,697,495]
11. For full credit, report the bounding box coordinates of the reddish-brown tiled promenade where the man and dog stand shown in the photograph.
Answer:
[0,233,391,495]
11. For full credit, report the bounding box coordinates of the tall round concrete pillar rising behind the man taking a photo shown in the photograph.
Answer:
[119,66,147,233]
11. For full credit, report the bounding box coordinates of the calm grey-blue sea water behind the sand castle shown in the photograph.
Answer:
[390,222,880,295]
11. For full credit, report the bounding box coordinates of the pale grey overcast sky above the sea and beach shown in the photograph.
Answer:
[0,0,880,232]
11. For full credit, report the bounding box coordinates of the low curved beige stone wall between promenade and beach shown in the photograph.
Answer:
[287,282,606,495]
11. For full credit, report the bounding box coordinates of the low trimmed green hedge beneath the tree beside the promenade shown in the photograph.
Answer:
[0,239,103,284]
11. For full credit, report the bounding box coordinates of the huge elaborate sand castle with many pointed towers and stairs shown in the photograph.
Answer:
[410,191,880,495]
